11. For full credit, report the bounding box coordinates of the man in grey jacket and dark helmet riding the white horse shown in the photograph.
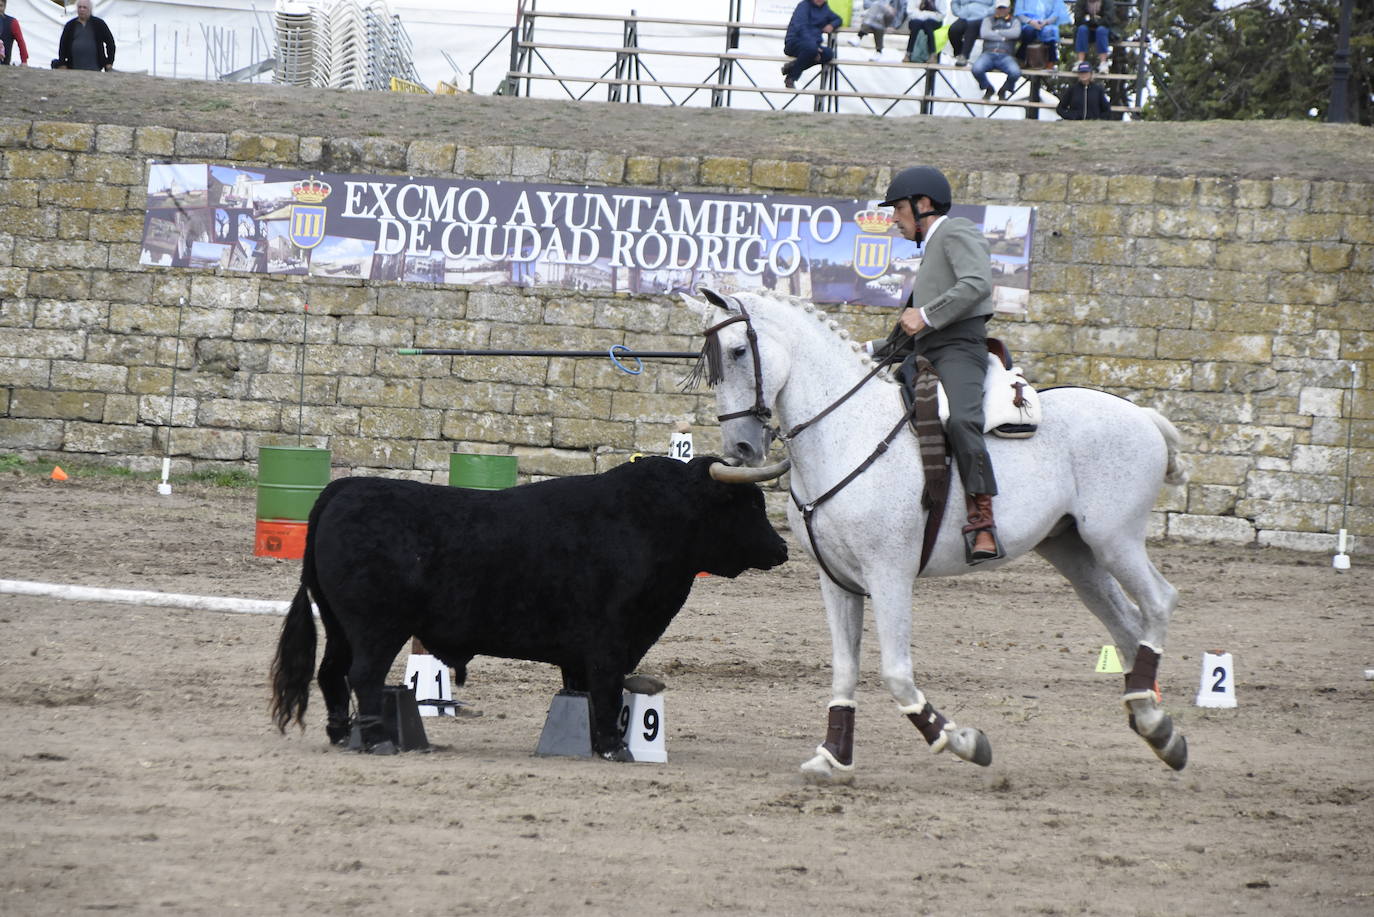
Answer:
[874,165,1003,564]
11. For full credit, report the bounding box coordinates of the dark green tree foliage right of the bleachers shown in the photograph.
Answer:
[1145,0,1374,124]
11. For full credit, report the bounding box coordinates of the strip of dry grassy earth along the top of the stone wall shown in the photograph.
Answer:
[8,67,1374,181]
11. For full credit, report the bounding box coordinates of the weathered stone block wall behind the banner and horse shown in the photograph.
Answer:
[0,118,1374,550]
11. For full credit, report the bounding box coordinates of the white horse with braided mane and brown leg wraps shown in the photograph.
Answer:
[684,289,1187,782]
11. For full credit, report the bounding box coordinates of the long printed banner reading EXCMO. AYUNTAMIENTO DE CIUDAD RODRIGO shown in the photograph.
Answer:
[140,162,1035,312]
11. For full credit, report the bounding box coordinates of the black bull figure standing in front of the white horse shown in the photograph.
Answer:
[272,456,787,760]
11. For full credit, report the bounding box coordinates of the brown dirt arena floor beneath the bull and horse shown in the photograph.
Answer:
[0,473,1374,916]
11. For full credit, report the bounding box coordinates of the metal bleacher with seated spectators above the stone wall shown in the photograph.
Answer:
[500,0,1150,118]
